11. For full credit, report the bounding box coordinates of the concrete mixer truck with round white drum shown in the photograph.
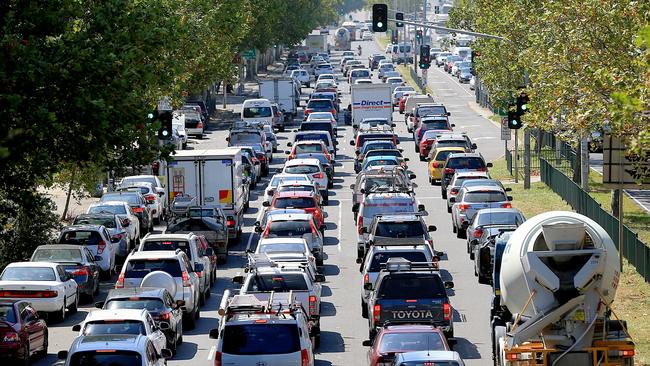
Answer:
[491,211,635,366]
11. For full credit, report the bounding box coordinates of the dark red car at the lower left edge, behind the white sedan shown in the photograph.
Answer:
[0,300,48,365]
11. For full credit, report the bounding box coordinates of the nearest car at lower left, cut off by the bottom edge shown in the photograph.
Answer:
[57,334,172,366]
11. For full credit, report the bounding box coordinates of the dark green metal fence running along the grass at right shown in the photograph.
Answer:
[540,158,650,283]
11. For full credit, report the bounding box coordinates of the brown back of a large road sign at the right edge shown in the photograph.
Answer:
[603,134,650,189]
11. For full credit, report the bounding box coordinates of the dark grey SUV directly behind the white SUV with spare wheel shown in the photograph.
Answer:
[95,287,185,353]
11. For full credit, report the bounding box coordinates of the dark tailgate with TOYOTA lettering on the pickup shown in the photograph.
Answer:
[377,299,444,323]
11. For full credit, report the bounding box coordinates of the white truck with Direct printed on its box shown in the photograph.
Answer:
[351,84,393,128]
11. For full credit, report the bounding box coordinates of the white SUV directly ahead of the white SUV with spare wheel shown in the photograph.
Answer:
[138,233,212,305]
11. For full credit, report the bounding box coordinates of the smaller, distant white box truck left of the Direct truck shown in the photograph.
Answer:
[258,77,300,123]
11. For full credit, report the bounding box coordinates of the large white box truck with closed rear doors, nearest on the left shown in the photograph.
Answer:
[166,148,249,242]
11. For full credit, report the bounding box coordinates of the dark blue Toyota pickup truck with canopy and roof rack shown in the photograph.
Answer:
[364,258,454,339]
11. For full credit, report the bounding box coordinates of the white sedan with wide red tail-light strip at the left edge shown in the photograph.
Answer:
[0,262,79,322]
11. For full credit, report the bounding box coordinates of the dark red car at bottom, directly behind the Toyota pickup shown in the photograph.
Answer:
[363,324,451,366]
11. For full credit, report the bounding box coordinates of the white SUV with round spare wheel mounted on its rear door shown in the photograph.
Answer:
[115,249,203,329]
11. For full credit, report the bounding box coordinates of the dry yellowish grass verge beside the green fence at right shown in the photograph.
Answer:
[490,158,650,365]
